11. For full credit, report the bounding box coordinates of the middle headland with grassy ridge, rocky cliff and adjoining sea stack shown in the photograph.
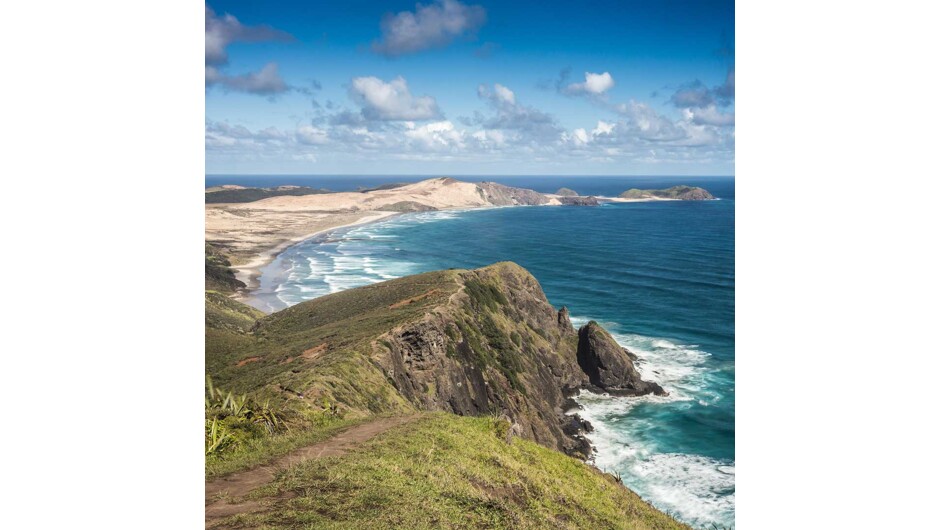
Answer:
[207,262,662,457]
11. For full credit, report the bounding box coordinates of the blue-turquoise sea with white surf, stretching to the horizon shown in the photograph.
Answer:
[206,176,735,527]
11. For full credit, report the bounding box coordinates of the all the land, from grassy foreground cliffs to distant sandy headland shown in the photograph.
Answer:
[205,178,713,528]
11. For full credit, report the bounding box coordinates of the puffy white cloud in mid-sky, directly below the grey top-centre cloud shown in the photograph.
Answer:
[349,76,441,121]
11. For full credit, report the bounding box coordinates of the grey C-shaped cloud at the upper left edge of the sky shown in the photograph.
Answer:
[206,5,293,96]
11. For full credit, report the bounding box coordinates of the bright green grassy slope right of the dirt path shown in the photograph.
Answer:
[227,413,687,529]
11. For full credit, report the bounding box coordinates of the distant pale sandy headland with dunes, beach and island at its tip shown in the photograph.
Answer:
[205,177,714,290]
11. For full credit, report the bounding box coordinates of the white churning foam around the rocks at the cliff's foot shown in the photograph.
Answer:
[571,317,735,526]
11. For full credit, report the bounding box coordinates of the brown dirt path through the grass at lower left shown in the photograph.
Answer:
[206,416,417,528]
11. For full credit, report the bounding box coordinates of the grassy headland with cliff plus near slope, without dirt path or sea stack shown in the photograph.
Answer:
[205,256,684,528]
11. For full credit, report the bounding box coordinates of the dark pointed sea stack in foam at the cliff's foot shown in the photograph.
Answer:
[578,320,666,396]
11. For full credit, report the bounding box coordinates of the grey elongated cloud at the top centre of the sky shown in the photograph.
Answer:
[372,0,486,56]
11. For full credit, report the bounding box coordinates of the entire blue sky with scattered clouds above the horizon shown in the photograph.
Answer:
[206,0,734,175]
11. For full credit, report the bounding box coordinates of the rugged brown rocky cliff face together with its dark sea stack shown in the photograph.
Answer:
[376,263,663,456]
